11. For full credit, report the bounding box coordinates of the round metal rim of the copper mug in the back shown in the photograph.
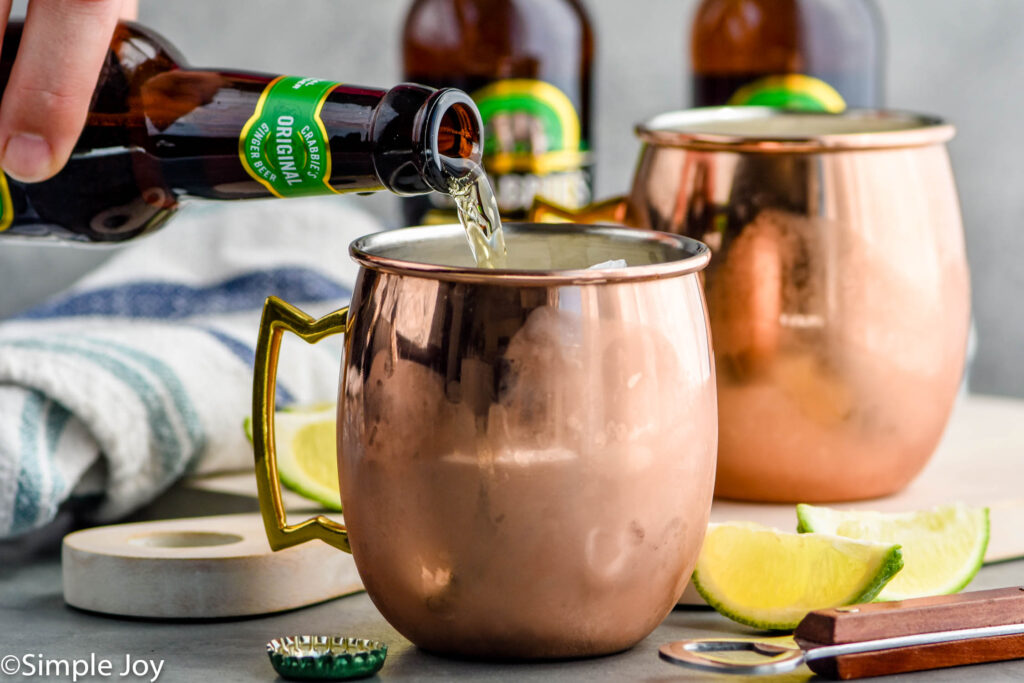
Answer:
[635,106,956,154]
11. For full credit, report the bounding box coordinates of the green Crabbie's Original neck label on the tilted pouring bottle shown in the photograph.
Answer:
[239,76,340,197]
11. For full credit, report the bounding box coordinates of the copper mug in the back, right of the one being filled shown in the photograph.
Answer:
[534,108,970,502]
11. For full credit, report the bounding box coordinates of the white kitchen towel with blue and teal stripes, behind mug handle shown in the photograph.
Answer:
[0,198,380,539]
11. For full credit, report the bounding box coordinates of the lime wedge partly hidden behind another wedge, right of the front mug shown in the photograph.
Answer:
[797,504,988,600]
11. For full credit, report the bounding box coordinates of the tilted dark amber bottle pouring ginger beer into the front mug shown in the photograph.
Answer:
[0,23,482,242]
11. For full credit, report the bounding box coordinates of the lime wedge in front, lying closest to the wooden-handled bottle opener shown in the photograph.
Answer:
[693,522,903,630]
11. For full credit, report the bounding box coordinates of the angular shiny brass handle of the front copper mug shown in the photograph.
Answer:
[253,297,352,553]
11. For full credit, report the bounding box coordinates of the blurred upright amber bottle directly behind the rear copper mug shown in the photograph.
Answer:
[689,0,884,112]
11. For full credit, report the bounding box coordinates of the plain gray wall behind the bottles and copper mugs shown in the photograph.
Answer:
[0,0,1024,396]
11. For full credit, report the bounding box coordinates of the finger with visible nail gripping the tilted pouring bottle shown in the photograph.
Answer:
[0,0,121,182]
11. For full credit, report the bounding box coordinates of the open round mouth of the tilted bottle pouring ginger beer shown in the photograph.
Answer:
[415,88,483,194]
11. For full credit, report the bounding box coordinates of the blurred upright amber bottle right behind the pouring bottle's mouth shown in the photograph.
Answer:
[402,0,594,224]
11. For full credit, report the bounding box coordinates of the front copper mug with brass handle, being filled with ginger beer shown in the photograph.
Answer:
[253,224,717,658]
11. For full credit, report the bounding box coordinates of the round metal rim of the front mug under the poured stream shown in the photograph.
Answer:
[348,222,711,287]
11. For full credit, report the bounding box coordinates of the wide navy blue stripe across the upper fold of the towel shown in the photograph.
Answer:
[17,267,351,321]
